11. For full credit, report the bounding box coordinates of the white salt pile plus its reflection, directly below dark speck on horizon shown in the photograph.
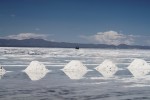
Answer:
[62,60,88,80]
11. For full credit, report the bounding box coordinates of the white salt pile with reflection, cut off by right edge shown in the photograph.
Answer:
[128,59,150,77]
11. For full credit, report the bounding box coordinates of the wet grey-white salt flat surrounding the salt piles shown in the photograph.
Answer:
[0,48,150,100]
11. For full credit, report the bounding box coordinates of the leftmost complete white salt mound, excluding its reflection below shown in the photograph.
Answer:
[25,61,49,73]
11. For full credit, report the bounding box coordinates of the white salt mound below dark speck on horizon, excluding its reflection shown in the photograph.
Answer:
[63,60,87,71]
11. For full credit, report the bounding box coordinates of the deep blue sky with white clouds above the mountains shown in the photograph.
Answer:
[0,0,150,45]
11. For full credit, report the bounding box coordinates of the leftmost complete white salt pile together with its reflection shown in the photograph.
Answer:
[24,61,50,81]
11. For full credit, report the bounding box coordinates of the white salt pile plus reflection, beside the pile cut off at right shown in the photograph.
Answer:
[95,60,118,77]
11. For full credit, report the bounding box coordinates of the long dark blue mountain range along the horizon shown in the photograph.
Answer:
[0,39,150,49]
